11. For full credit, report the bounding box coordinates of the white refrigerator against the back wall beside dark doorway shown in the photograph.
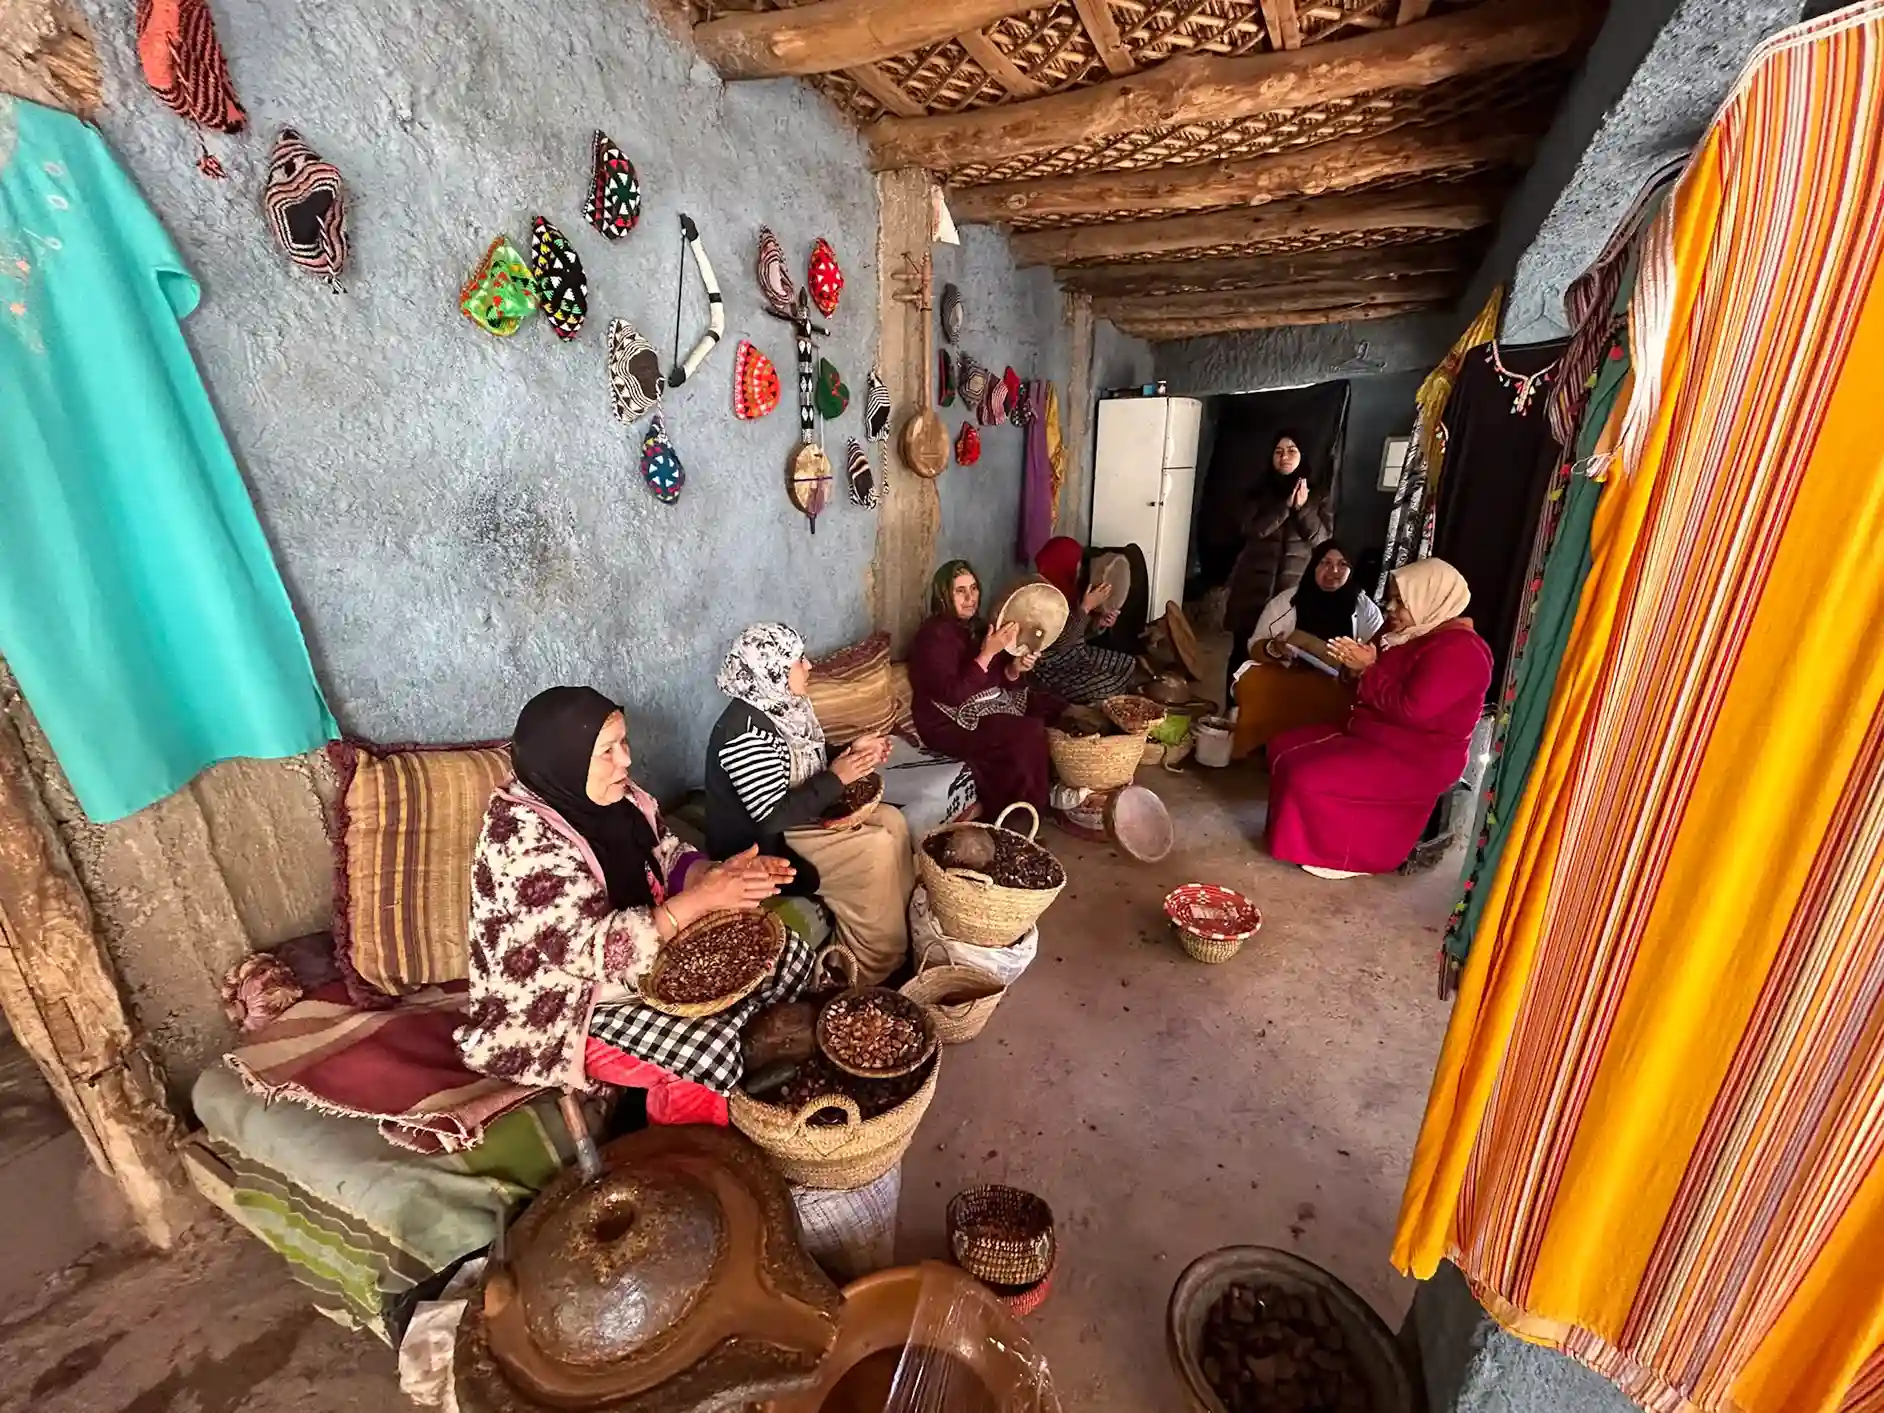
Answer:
[1091,398,1204,618]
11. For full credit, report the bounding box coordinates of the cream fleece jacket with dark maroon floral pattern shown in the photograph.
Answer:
[458,780,703,1089]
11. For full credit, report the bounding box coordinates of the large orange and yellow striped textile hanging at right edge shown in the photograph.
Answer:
[1394,0,1884,1413]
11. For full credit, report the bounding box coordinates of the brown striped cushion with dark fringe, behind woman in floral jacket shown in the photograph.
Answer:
[333,744,511,997]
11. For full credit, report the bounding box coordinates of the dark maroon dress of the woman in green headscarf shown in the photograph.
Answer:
[910,614,1066,820]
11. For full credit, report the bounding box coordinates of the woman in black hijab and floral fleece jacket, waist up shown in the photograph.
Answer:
[458,688,791,1089]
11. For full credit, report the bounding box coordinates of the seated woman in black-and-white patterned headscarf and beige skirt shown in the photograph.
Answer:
[707,624,916,985]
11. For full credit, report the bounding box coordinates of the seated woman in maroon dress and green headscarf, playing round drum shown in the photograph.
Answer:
[910,560,1066,820]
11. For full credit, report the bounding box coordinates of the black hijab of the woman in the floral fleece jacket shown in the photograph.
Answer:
[511,688,656,910]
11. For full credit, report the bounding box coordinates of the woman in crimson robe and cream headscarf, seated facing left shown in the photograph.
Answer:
[1268,560,1492,878]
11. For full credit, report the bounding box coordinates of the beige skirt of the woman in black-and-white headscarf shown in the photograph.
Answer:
[786,804,916,985]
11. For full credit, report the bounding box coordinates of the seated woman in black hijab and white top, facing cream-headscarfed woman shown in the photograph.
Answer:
[1230,539,1381,757]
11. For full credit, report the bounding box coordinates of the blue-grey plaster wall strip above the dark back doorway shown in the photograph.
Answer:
[1153,313,1460,398]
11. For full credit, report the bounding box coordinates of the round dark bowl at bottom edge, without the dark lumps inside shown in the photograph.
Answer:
[1164,1245,1419,1413]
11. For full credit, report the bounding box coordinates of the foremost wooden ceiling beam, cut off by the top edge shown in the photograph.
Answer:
[693,0,1040,79]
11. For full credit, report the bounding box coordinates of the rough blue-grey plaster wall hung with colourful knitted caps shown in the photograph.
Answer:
[69,0,1057,791]
